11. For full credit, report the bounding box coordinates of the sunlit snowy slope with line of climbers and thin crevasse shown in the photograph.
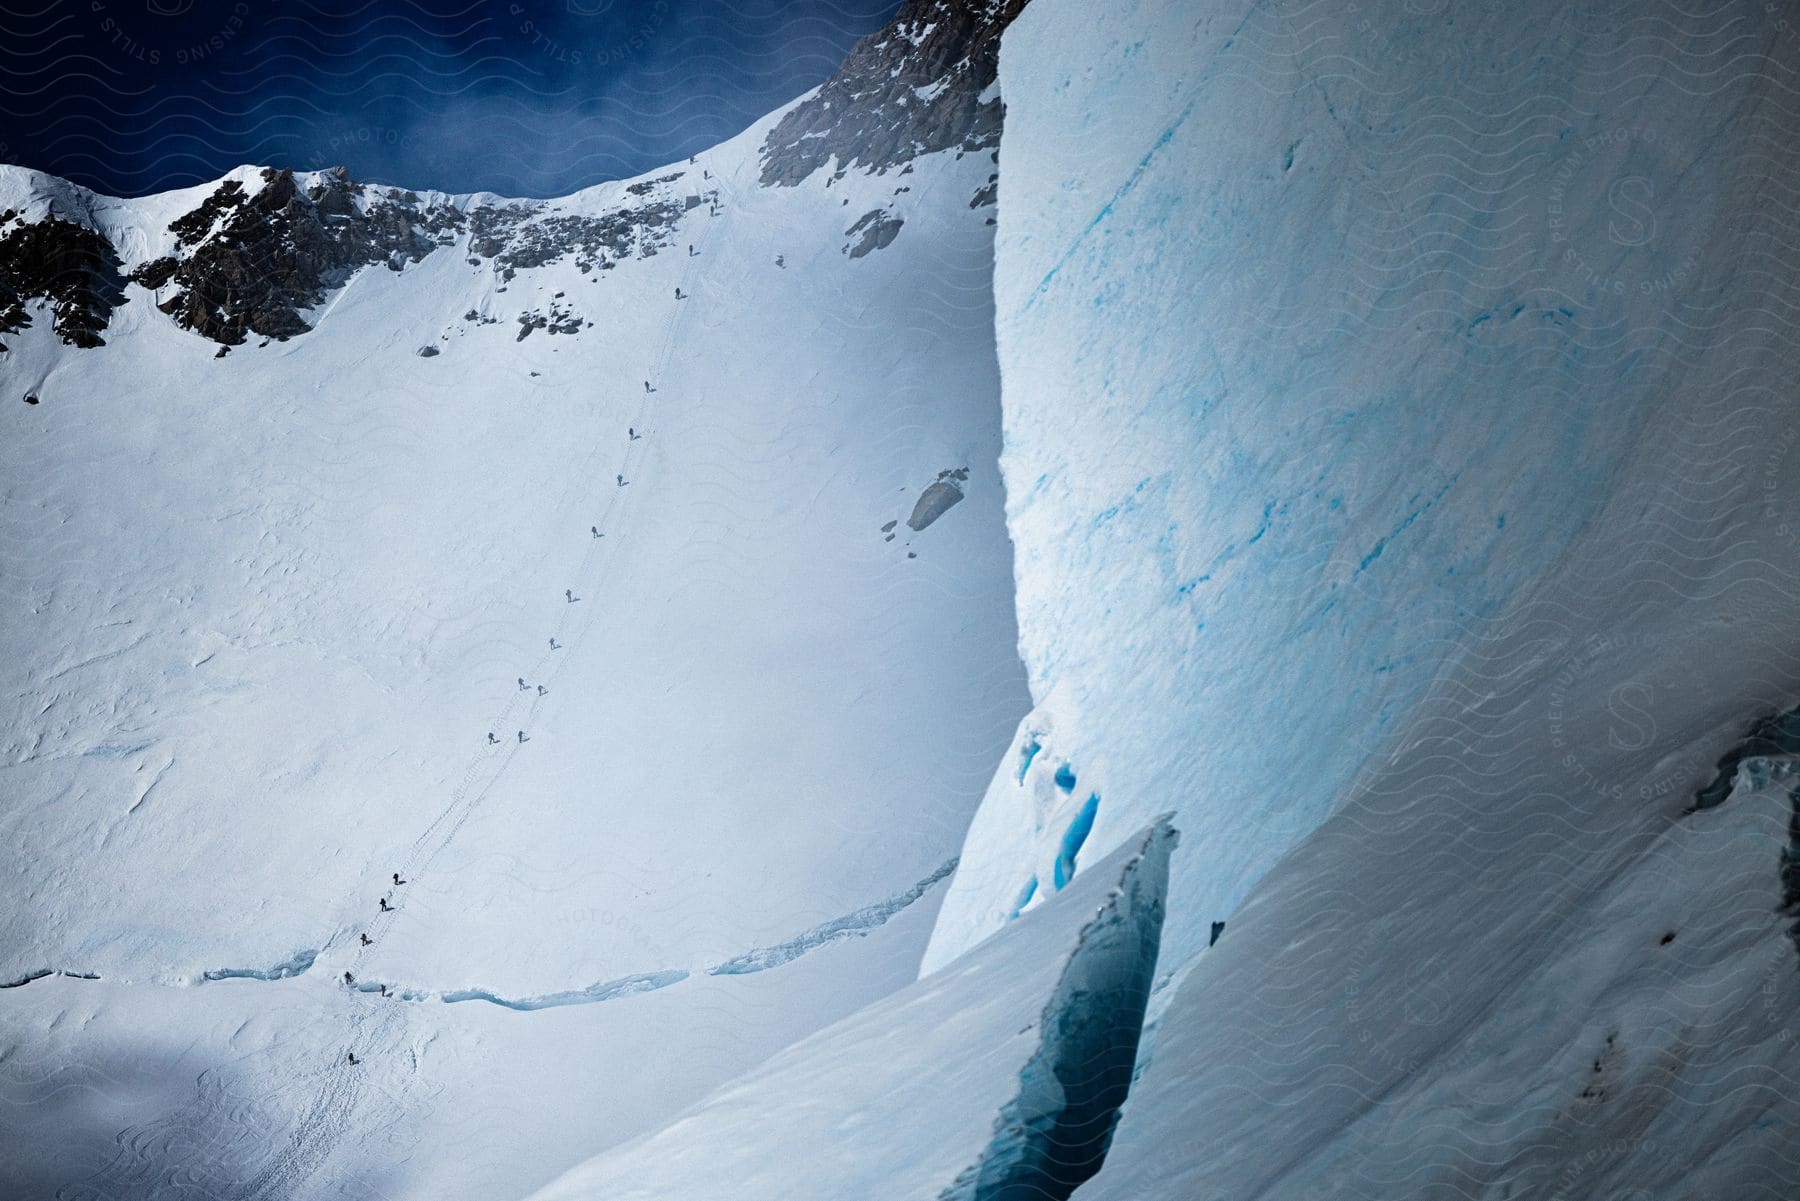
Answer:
[0,4,1026,1197]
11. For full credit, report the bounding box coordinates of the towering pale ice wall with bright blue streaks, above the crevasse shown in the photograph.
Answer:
[925,0,1800,972]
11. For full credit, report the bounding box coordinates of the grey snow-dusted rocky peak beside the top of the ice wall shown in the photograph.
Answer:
[761,0,1028,185]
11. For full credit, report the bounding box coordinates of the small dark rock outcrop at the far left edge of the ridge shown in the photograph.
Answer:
[0,209,126,349]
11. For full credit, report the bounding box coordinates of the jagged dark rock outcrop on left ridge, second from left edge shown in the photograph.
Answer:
[131,167,466,346]
